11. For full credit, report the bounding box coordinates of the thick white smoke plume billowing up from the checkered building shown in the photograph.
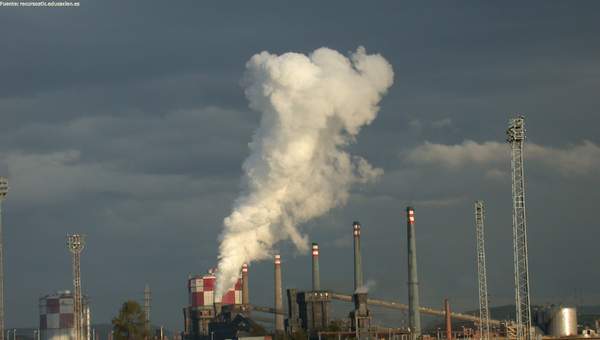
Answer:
[216,47,394,296]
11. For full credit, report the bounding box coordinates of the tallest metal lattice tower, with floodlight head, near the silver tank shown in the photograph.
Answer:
[506,116,532,340]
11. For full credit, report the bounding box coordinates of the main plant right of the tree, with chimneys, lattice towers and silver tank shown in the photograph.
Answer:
[176,116,597,340]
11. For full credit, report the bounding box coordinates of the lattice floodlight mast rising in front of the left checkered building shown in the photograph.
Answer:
[67,234,85,340]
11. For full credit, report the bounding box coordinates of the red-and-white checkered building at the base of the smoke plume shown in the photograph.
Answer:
[183,269,243,339]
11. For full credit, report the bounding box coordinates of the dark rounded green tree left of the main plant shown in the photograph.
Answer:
[112,300,149,340]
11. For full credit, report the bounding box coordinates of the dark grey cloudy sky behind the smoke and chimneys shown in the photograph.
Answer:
[0,0,600,329]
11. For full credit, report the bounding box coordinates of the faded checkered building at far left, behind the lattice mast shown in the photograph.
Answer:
[39,290,90,340]
